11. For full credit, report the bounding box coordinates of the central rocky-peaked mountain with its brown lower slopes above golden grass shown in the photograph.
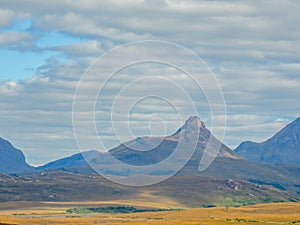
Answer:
[0,117,300,207]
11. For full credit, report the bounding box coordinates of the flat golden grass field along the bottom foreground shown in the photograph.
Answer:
[0,202,300,225]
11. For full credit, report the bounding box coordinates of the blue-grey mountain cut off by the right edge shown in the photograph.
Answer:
[235,117,300,165]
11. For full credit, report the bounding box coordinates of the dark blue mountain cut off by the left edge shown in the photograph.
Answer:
[0,138,34,174]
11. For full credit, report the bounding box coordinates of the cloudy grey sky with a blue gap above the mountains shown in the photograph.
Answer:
[0,0,300,165]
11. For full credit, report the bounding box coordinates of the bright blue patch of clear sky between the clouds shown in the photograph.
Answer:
[0,18,84,81]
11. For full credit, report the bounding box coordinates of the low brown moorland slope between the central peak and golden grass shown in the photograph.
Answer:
[0,172,300,208]
